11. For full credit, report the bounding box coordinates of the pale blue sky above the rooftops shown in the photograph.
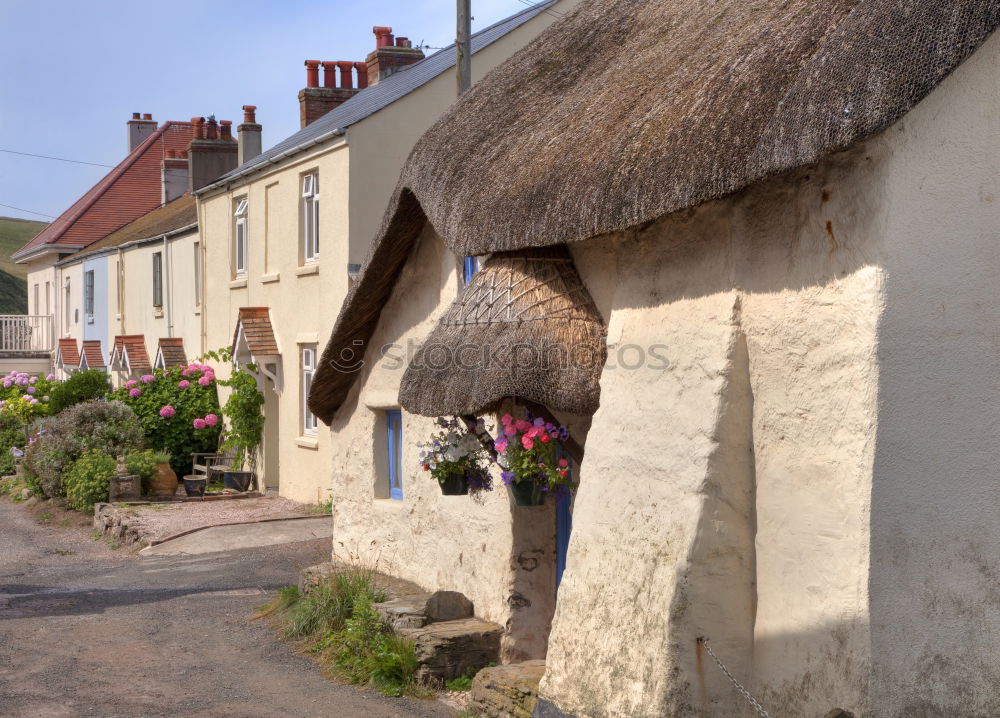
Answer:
[0,0,529,225]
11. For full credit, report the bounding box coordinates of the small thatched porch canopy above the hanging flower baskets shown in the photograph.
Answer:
[399,247,607,416]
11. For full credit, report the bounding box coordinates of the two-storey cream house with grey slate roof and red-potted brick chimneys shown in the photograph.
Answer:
[193,0,576,502]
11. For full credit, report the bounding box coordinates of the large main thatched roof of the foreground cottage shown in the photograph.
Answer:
[310,0,1000,428]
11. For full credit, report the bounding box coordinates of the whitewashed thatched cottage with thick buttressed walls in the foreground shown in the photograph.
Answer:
[310,0,1000,718]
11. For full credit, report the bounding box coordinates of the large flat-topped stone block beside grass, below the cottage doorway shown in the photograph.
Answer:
[397,618,503,684]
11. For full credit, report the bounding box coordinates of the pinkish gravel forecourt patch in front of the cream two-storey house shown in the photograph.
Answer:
[121,498,316,541]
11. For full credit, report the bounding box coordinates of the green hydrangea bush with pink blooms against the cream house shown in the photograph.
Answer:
[111,363,222,476]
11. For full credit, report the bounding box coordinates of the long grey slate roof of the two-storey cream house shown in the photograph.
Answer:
[203,0,557,194]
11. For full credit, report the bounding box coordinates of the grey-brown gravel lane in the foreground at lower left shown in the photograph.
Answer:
[0,501,454,718]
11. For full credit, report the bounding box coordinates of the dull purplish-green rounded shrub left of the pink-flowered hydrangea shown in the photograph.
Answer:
[23,401,145,498]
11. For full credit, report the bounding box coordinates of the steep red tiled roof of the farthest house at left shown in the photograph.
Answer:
[12,121,193,260]
